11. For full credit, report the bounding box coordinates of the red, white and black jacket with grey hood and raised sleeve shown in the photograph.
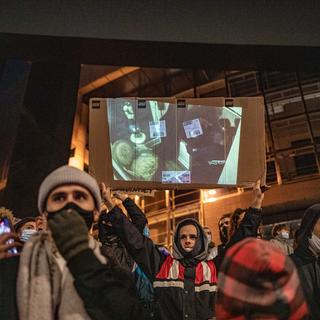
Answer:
[110,207,217,320]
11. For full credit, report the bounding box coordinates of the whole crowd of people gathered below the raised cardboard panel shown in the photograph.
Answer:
[0,166,320,320]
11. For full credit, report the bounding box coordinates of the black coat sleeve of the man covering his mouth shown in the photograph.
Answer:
[68,249,146,320]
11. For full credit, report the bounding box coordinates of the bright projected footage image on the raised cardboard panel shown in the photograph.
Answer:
[107,98,242,185]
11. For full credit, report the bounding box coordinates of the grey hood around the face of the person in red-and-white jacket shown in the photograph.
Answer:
[173,218,208,261]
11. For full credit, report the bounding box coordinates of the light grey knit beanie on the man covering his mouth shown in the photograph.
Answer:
[38,165,101,213]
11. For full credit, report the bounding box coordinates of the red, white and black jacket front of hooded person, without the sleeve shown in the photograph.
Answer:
[153,256,217,320]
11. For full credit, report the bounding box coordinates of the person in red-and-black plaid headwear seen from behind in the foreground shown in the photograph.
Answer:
[216,238,308,320]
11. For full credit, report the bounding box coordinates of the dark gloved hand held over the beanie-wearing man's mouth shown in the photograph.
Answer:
[48,209,89,262]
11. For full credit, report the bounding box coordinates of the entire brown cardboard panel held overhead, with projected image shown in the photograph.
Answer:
[89,98,265,189]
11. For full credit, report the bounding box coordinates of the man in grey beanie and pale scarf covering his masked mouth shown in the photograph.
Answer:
[13,166,143,320]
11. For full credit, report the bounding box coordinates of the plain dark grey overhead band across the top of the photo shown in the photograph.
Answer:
[0,0,320,47]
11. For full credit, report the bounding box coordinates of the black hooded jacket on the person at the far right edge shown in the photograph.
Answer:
[291,204,320,320]
